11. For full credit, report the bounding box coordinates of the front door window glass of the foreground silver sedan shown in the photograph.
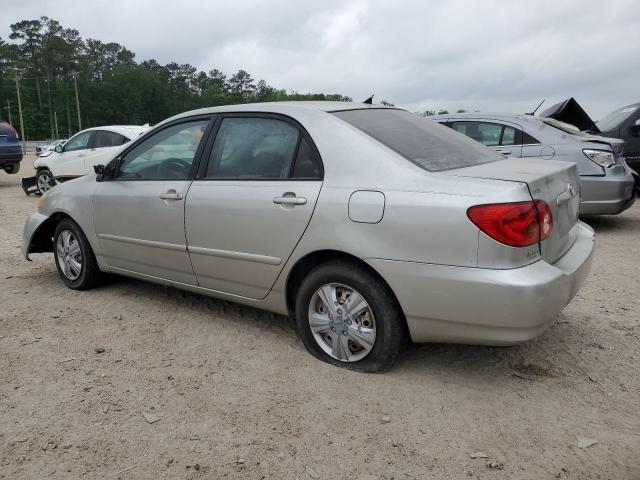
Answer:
[118,120,209,180]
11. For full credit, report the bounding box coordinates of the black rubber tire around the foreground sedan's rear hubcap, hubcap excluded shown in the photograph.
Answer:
[295,261,405,372]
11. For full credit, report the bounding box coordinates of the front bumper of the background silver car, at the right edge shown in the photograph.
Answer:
[580,166,636,215]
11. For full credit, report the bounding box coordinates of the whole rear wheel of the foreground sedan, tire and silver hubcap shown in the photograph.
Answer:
[295,260,406,372]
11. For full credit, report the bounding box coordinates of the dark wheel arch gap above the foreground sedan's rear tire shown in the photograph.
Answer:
[285,250,408,331]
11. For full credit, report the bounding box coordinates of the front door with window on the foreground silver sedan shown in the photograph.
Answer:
[93,116,210,285]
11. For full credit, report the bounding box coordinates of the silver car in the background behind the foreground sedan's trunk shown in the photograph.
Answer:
[430,113,636,215]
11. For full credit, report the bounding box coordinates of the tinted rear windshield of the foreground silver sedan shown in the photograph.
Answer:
[333,109,504,172]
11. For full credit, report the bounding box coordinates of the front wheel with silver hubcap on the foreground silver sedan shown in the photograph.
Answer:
[53,218,102,290]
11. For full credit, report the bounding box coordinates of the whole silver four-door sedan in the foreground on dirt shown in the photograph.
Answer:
[23,102,594,371]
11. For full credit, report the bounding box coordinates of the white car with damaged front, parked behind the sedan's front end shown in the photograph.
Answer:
[33,125,150,193]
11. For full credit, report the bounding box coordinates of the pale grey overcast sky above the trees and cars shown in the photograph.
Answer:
[0,0,640,119]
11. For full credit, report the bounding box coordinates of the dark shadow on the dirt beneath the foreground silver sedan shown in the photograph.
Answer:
[96,276,573,383]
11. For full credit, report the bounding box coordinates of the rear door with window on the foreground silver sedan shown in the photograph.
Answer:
[185,114,323,299]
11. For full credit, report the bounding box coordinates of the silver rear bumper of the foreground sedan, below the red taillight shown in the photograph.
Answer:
[367,223,595,345]
